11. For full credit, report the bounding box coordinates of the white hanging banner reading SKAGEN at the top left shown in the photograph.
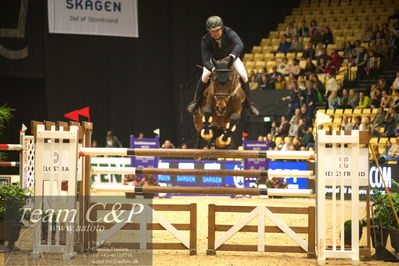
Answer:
[48,0,139,37]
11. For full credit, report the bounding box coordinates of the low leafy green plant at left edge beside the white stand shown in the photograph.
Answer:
[0,184,30,221]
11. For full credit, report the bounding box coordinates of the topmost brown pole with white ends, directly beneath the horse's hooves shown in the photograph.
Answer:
[79,148,314,160]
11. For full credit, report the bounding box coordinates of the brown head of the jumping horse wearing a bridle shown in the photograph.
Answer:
[212,58,234,116]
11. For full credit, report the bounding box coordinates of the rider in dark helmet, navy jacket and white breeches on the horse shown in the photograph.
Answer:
[187,16,259,115]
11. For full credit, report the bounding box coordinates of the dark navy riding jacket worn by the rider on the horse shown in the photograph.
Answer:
[201,27,244,71]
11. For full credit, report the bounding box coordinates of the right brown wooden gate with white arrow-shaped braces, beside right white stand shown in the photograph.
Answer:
[207,204,316,257]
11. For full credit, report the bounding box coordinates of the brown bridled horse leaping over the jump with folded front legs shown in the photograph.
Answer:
[193,58,245,148]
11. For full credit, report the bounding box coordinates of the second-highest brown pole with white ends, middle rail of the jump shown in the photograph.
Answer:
[91,167,313,178]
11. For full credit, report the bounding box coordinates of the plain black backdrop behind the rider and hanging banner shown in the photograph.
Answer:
[0,0,298,151]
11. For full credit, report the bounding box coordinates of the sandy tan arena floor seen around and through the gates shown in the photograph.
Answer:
[0,197,394,266]
